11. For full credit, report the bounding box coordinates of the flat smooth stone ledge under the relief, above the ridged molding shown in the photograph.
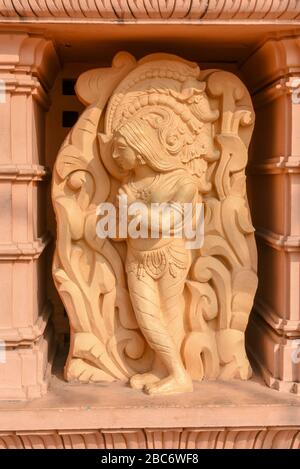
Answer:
[0,365,300,433]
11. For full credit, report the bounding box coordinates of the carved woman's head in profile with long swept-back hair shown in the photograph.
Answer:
[112,117,183,172]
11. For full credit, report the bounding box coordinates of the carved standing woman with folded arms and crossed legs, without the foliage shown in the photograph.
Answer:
[112,118,198,394]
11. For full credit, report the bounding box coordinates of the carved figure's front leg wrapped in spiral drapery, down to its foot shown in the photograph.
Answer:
[128,273,193,394]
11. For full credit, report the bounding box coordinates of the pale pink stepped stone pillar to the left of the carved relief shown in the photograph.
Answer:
[0,34,59,399]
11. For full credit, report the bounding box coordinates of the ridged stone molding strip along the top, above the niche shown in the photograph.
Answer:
[0,0,300,22]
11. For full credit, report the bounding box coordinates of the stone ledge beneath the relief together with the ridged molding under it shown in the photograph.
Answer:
[0,355,300,449]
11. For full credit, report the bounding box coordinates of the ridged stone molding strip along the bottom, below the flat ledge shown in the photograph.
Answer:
[0,427,300,449]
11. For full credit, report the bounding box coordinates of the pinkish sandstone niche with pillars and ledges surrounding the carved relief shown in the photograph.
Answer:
[0,0,300,448]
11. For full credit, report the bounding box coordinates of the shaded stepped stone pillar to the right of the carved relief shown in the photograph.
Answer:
[242,36,300,393]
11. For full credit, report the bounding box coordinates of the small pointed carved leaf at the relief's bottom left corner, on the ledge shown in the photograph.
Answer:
[64,358,115,383]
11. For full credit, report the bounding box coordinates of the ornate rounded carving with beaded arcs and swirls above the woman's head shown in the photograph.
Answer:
[104,55,219,181]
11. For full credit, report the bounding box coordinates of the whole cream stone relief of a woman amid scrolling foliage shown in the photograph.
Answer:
[52,52,257,394]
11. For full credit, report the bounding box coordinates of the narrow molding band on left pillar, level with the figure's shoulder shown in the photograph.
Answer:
[0,164,50,181]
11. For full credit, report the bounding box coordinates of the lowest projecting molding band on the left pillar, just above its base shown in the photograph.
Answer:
[0,301,53,347]
